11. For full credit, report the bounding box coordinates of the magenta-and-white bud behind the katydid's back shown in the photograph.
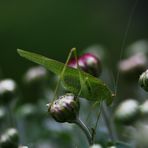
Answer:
[68,53,102,77]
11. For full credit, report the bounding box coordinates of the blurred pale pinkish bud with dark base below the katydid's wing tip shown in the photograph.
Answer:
[23,66,47,103]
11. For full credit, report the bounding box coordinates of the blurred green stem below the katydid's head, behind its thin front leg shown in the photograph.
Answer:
[102,102,117,142]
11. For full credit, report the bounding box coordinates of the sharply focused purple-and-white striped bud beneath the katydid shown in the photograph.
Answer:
[48,93,80,123]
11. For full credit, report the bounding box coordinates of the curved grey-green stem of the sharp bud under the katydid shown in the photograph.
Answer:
[74,118,93,146]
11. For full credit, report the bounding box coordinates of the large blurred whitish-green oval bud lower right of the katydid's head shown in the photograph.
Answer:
[115,99,139,125]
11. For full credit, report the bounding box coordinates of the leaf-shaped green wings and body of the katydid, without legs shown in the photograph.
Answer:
[17,49,112,104]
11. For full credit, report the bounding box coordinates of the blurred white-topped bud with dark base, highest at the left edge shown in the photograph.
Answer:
[0,79,17,104]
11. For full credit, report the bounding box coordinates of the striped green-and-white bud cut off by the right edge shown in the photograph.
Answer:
[139,69,148,91]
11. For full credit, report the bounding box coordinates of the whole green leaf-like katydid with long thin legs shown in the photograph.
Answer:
[18,48,116,144]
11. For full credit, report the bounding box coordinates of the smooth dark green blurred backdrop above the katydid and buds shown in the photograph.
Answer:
[0,0,148,80]
